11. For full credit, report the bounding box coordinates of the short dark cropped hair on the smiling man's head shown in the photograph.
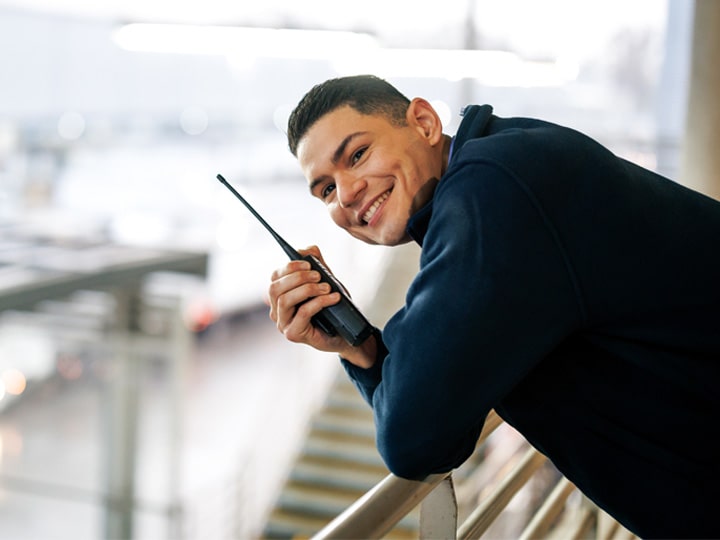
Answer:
[287,75,410,157]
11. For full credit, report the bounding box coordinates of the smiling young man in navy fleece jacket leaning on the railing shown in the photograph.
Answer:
[269,76,720,538]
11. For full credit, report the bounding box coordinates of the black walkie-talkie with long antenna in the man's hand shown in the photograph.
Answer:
[217,174,373,346]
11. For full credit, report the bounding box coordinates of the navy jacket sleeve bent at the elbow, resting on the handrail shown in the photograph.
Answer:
[346,162,583,478]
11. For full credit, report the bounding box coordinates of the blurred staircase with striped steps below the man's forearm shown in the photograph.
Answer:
[263,372,417,540]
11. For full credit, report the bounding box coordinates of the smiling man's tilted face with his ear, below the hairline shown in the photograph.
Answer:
[297,100,442,246]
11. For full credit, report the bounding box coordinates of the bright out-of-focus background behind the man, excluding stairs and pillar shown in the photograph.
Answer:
[0,0,693,539]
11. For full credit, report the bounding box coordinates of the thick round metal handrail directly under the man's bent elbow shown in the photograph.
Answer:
[313,411,502,540]
